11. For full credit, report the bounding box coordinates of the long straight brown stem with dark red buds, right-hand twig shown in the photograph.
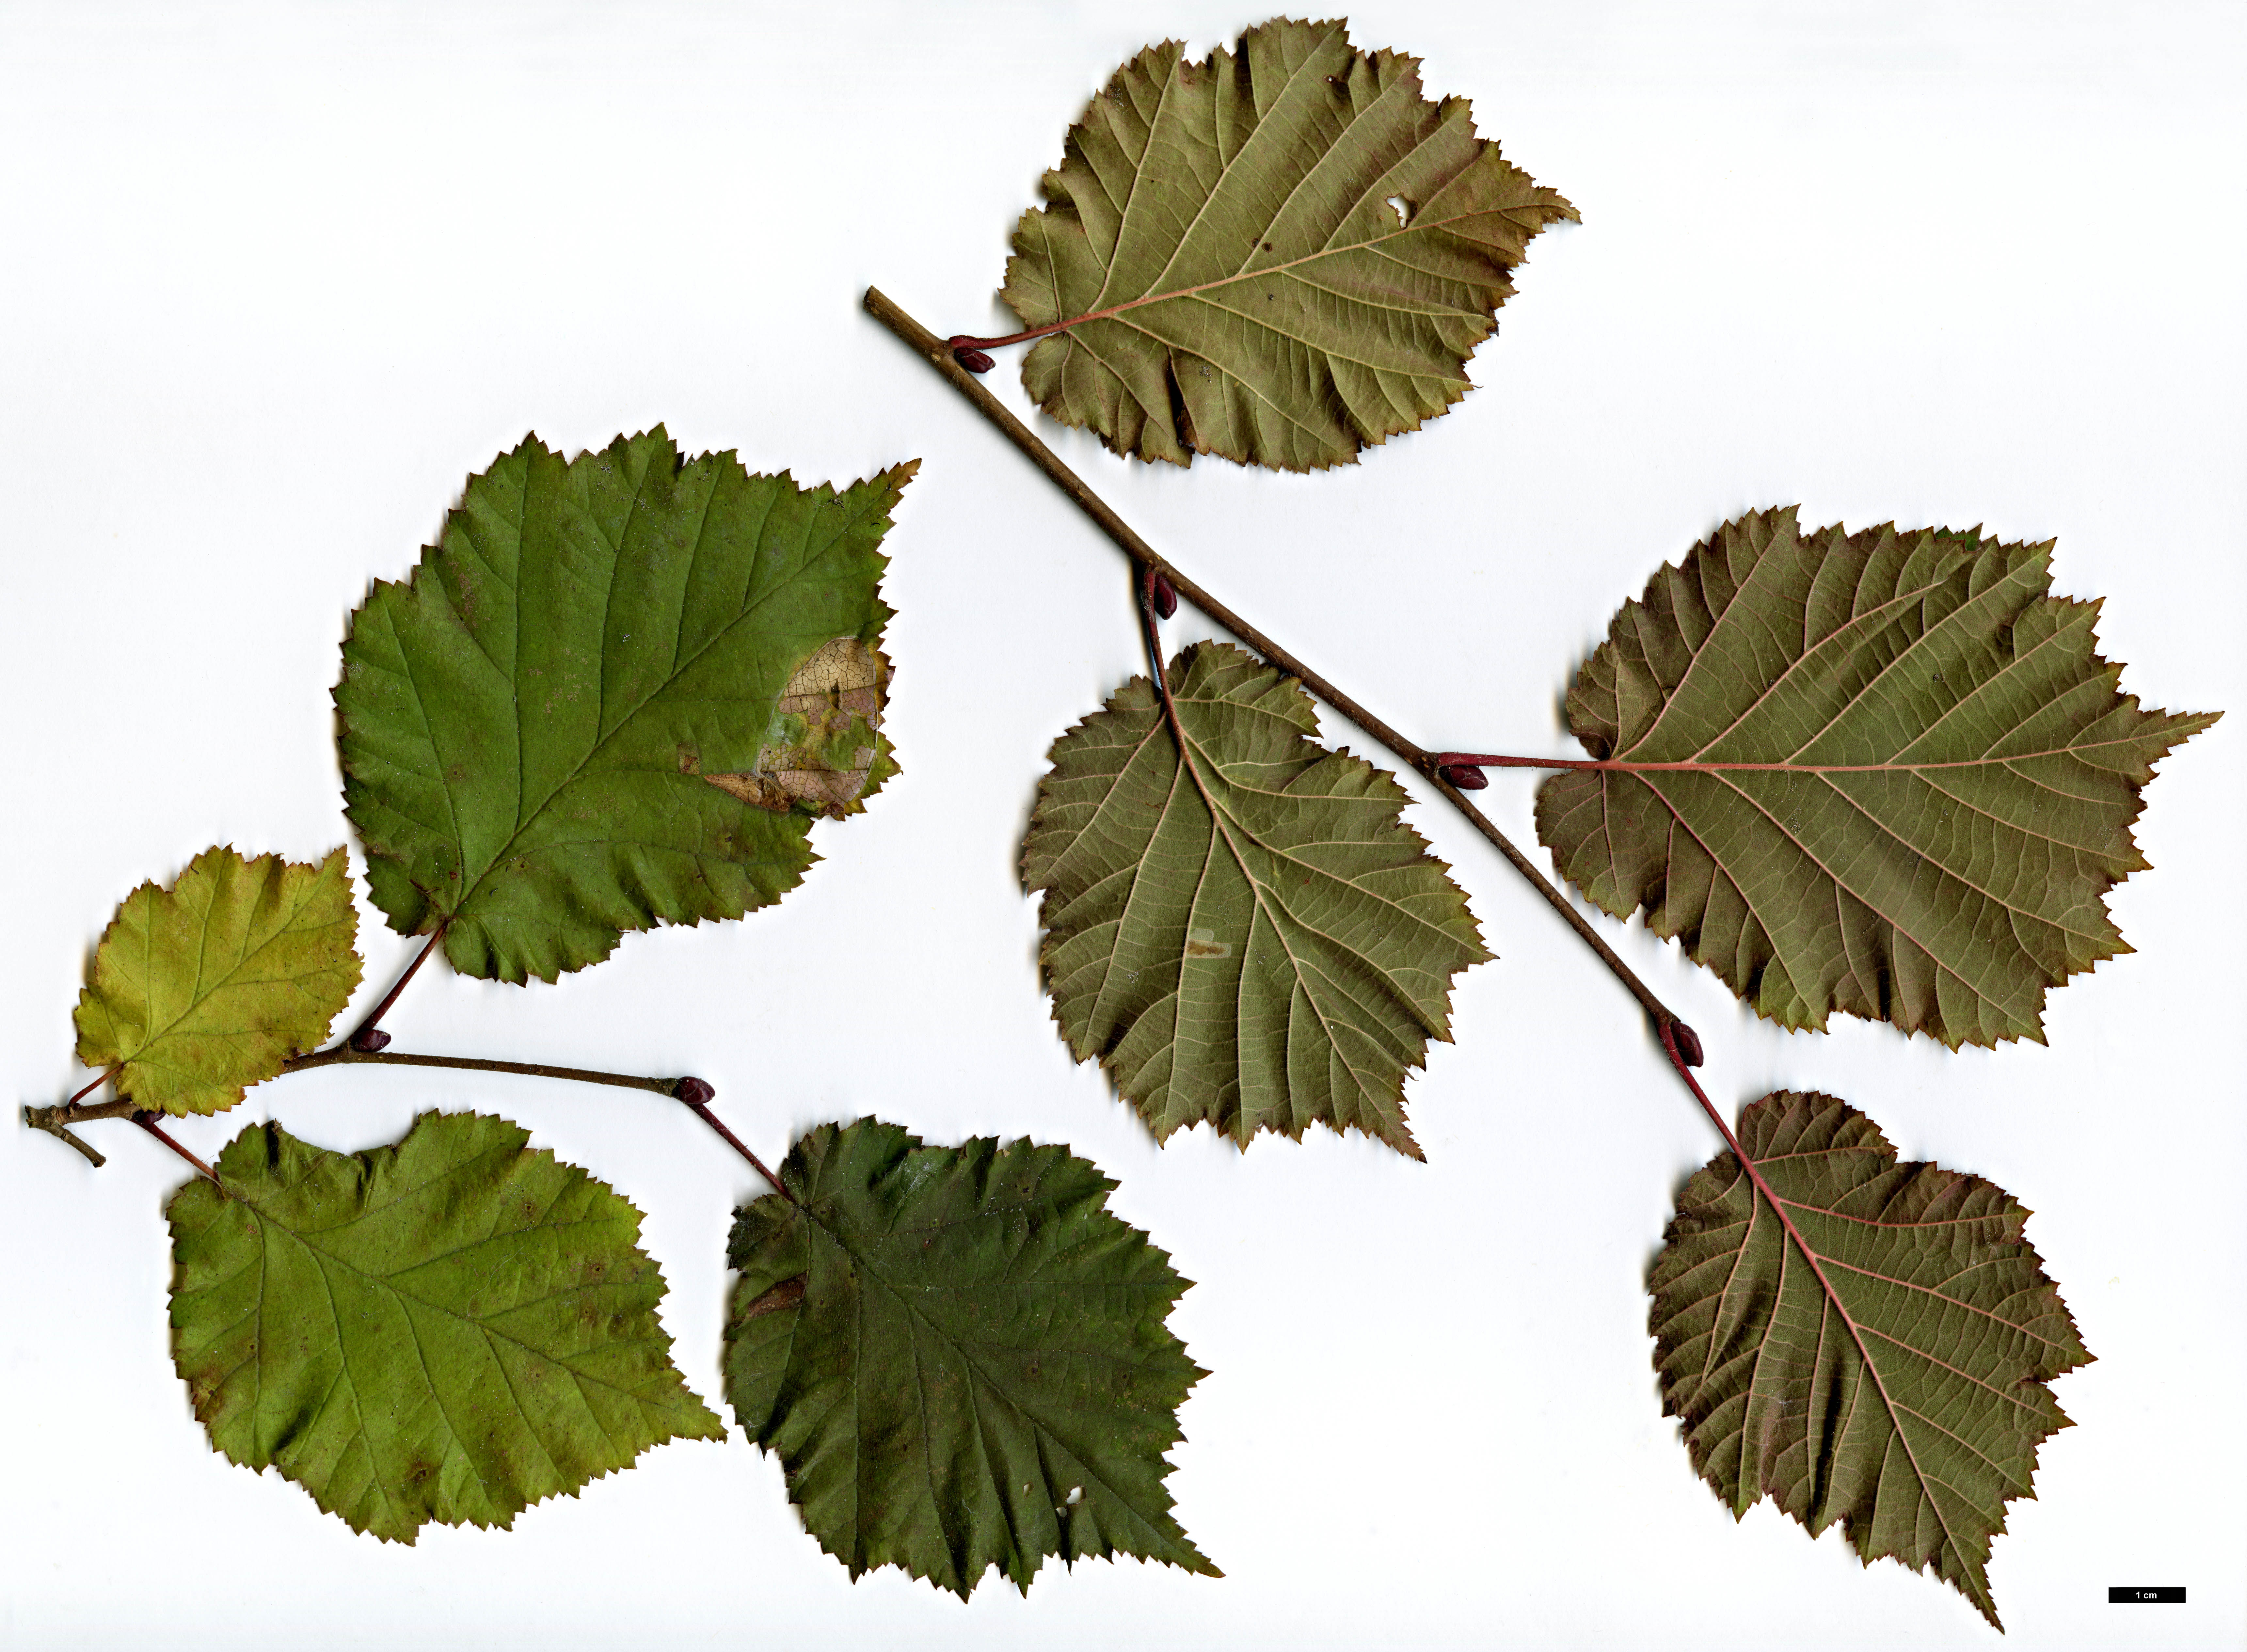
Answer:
[865,288,1701,1056]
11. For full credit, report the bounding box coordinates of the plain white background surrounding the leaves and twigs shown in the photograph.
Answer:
[0,0,2247,1650]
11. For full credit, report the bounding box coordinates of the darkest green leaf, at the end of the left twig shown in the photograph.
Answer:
[726,1119,1220,1596]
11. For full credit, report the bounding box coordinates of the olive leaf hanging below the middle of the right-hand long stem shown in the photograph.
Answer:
[1022,643,1490,1157]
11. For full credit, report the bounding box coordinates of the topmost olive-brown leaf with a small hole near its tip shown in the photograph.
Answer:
[1000,18,1575,470]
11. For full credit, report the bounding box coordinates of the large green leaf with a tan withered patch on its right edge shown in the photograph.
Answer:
[335,427,917,982]
